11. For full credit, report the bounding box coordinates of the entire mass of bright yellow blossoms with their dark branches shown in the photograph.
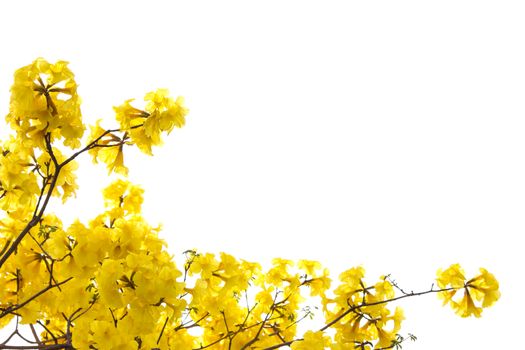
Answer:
[0,59,499,350]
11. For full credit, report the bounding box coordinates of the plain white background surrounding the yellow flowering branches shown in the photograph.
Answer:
[0,1,525,349]
